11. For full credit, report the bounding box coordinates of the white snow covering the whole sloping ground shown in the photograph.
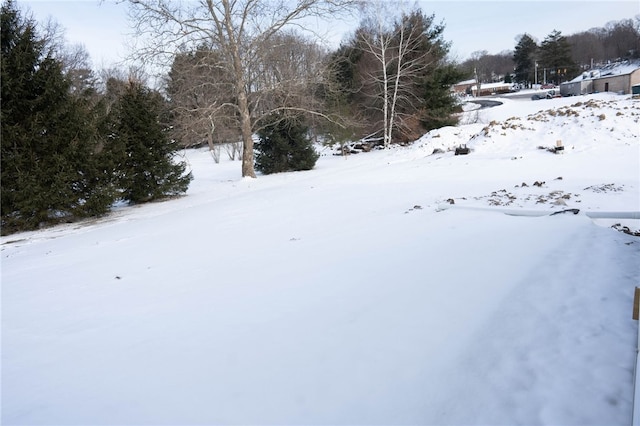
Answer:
[0,94,640,425]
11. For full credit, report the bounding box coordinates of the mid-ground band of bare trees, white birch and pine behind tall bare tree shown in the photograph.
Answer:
[164,0,462,155]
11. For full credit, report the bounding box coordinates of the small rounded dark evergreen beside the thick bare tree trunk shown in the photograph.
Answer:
[256,114,318,174]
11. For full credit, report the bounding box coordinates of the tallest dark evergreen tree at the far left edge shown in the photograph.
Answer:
[0,1,113,233]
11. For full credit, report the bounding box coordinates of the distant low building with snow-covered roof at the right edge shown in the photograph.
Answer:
[560,61,640,96]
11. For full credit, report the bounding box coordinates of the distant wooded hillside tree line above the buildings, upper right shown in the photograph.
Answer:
[460,16,640,86]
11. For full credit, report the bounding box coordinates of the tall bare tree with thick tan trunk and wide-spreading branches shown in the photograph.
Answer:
[124,0,356,177]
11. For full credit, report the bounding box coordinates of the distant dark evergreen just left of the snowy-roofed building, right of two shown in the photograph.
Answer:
[540,30,579,84]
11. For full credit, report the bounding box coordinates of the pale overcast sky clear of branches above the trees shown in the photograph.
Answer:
[17,0,640,68]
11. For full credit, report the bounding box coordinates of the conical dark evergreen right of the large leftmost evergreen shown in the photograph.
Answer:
[107,82,192,203]
